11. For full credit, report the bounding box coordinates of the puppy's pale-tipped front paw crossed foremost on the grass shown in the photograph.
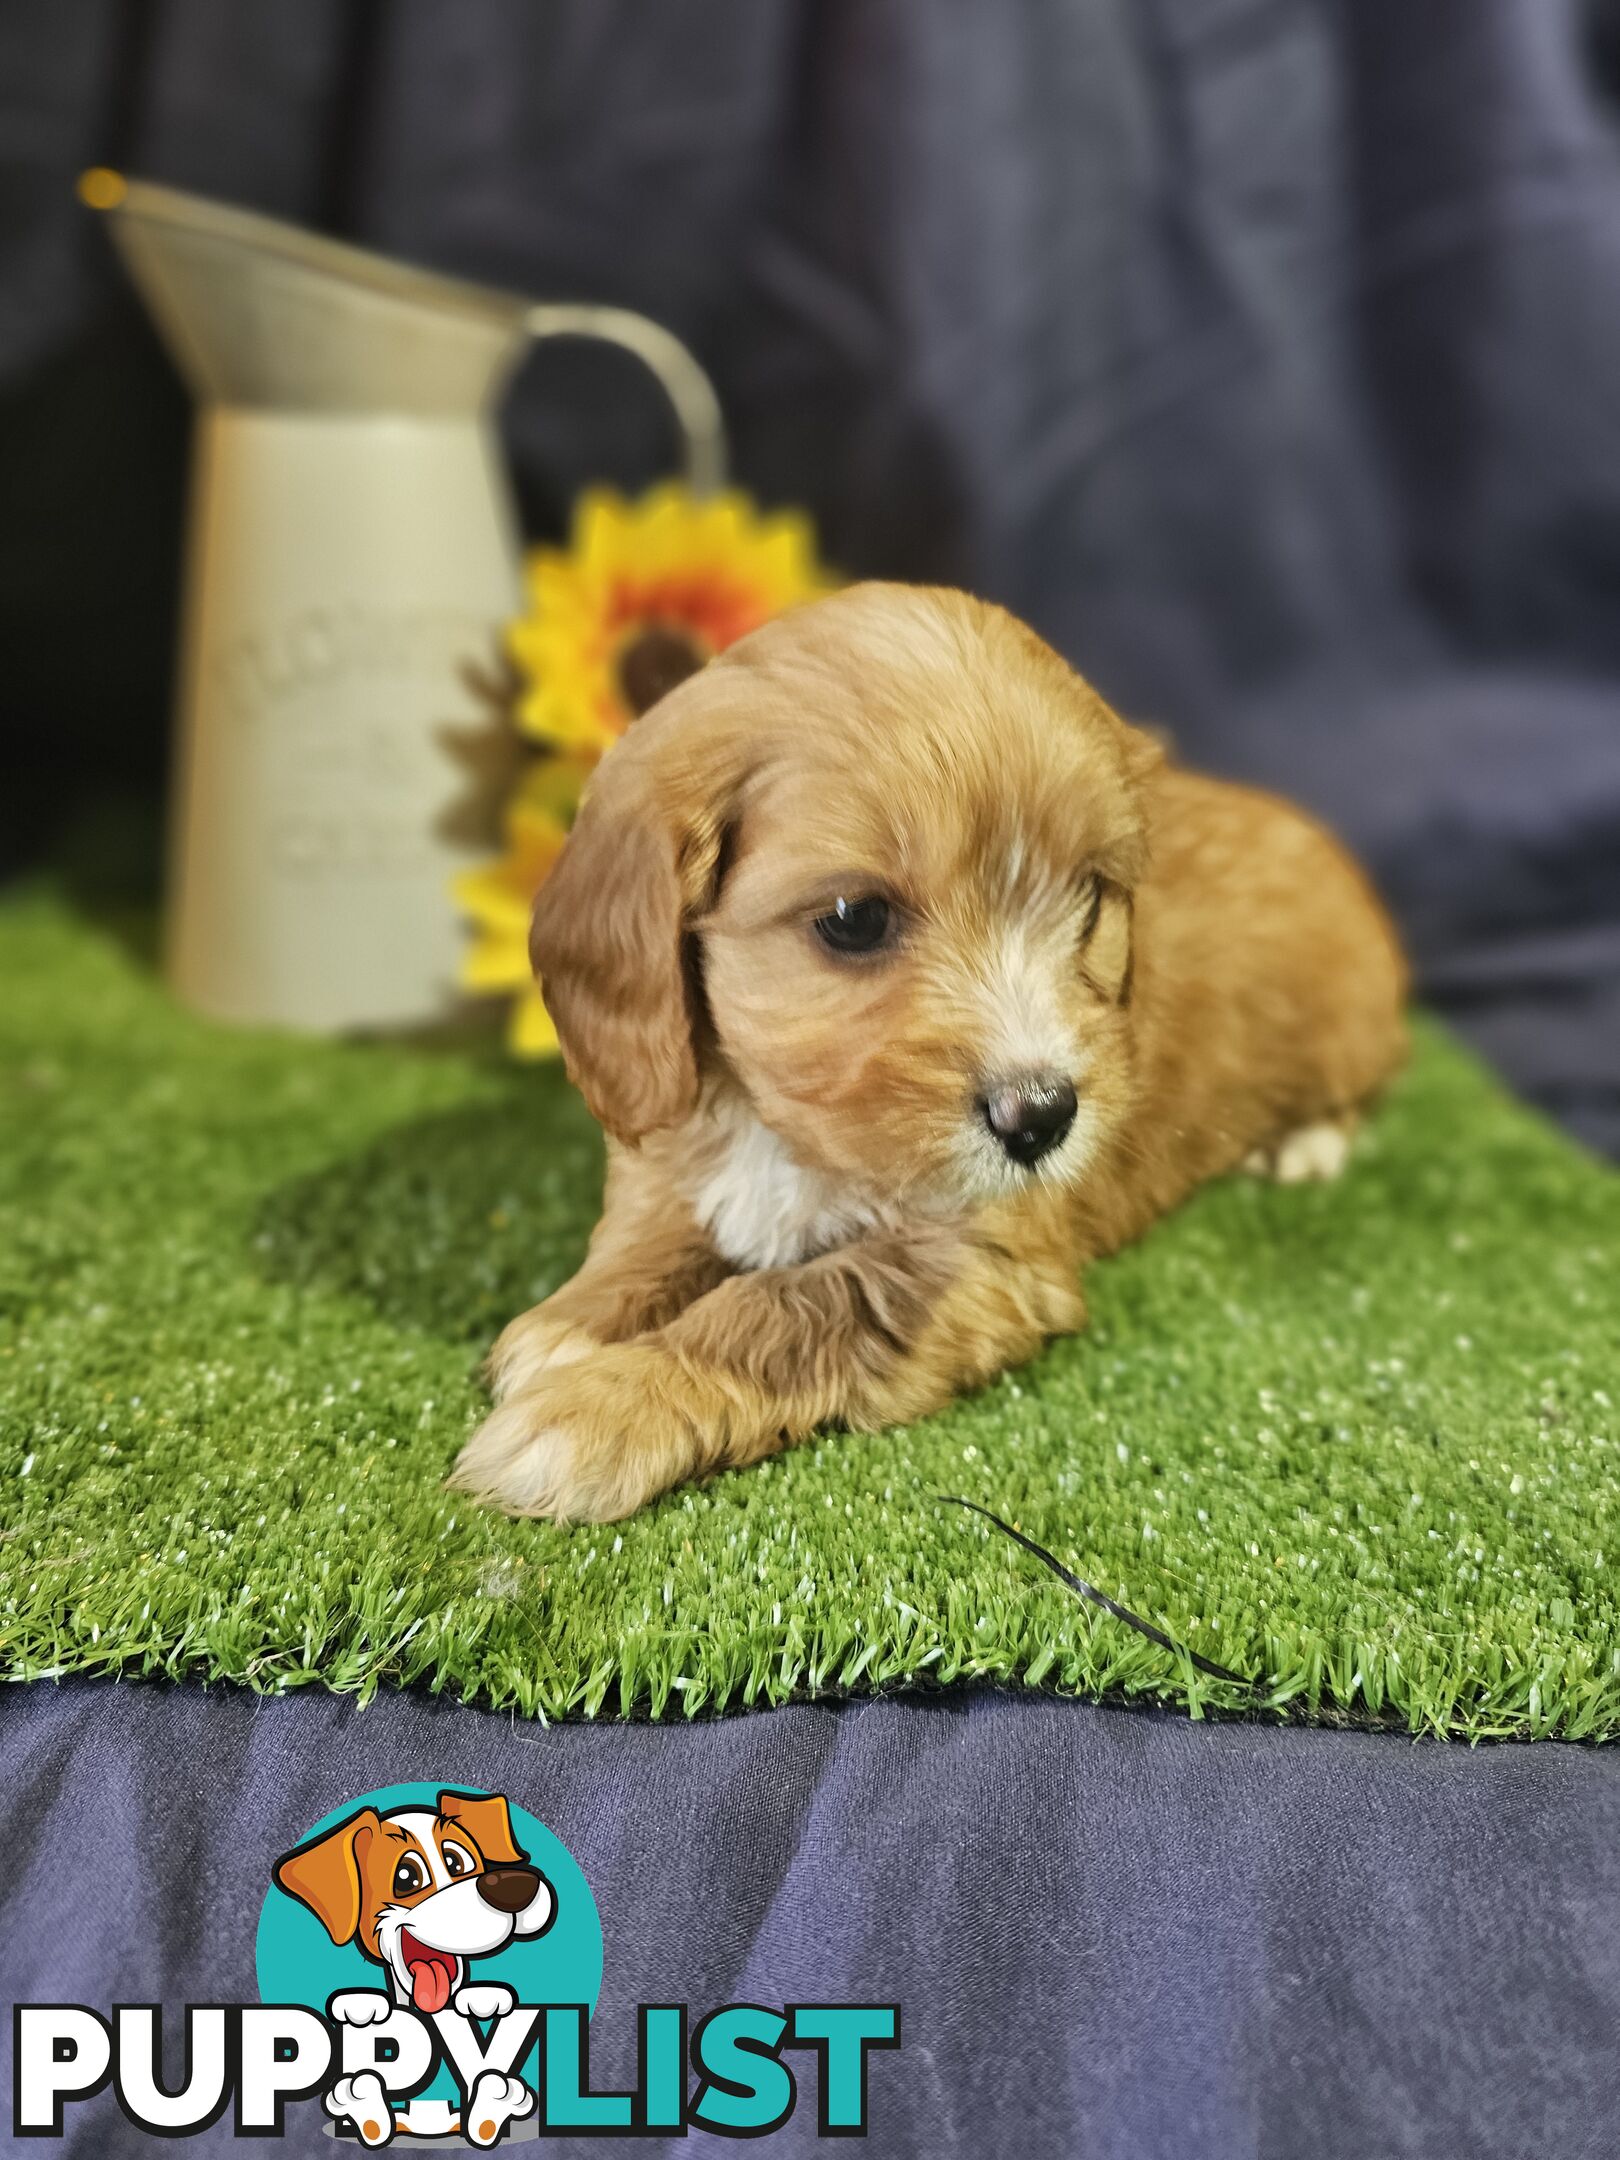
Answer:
[449,1344,719,1523]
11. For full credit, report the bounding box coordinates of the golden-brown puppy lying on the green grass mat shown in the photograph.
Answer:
[454,585,1406,1521]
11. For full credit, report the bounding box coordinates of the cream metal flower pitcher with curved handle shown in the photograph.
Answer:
[86,173,724,1030]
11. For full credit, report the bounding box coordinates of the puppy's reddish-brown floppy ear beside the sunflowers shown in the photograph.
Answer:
[529,663,730,1145]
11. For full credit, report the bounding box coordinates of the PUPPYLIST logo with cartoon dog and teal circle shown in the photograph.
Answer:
[13,1784,901,2149]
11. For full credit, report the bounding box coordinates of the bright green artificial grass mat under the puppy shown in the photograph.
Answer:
[0,890,1620,1739]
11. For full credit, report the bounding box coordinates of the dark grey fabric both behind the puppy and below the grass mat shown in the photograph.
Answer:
[0,0,1620,2160]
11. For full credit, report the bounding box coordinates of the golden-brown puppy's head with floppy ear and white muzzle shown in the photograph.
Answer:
[531,585,1158,1205]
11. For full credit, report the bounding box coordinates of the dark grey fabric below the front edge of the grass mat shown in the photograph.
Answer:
[0,1683,1620,2160]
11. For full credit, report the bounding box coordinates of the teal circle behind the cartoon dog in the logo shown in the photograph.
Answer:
[253,1780,603,2100]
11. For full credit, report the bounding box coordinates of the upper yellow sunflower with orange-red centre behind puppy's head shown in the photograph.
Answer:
[508,486,829,758]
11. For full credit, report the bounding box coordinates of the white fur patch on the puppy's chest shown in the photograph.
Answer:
[691,1104,883,1268]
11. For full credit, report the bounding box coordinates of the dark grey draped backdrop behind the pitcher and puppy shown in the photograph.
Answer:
[0,0,1620,1145]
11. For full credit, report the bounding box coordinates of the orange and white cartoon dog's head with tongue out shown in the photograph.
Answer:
[272,1793,557,2017]
